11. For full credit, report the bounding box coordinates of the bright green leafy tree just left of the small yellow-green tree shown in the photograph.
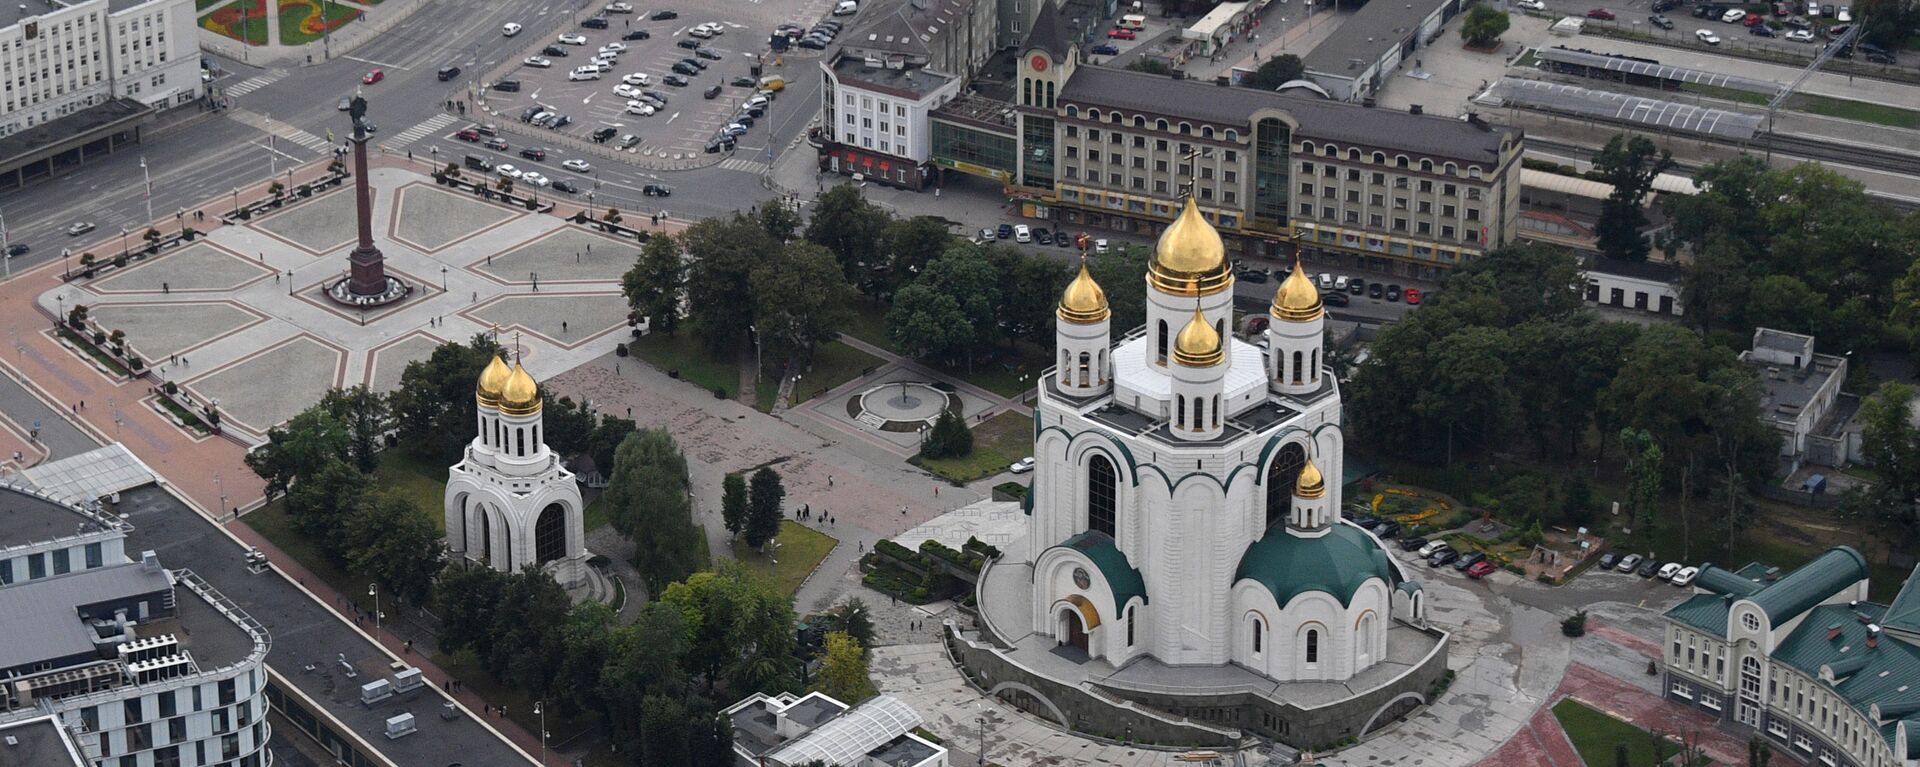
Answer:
[660,559,795,696]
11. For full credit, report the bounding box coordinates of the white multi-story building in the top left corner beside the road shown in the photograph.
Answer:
[0,0,202,183]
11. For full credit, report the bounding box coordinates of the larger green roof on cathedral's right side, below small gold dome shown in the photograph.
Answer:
[1233,523,1394,607]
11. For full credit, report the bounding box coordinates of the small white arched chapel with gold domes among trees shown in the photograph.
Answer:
[445,356,588,586]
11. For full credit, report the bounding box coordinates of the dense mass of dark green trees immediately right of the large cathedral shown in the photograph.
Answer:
[1348,248,1778,557]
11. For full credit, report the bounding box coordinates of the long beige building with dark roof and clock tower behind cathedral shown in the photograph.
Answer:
[929,2,1523,277]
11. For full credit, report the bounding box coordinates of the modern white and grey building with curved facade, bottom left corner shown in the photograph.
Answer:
[0,486,271,767]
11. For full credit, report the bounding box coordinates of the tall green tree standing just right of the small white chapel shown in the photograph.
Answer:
[605,429,703,594]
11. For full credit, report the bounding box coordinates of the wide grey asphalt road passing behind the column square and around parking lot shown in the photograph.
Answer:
[0,0,820,276]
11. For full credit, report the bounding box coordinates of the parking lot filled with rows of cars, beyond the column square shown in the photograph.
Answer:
[488,0,818,158]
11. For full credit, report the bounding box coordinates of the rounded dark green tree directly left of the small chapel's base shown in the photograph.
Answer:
[338,488,447,606]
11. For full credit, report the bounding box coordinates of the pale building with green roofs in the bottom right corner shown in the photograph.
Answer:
[1663,546,1920,767]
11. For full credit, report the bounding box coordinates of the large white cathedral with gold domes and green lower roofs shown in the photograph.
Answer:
[979,200,1446,726]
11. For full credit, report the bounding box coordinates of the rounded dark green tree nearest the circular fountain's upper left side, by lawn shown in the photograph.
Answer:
[753,242,852,381]
